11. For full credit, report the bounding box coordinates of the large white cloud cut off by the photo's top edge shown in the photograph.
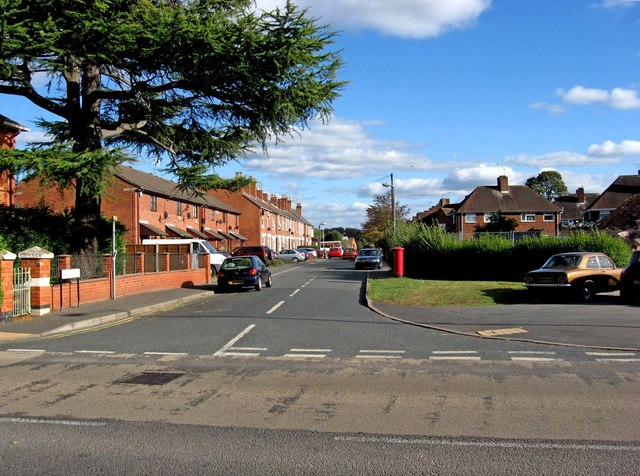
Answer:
[256,0,491,38]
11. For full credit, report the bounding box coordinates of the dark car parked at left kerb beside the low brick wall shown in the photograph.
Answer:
[218,255,272,291]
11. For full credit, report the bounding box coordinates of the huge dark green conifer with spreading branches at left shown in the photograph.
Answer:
[0,0,344,260]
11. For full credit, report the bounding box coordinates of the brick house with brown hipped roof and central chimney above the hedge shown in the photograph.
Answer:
[453,175,561,238]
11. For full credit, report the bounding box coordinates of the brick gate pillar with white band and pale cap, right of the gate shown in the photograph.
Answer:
[18,246,53,316]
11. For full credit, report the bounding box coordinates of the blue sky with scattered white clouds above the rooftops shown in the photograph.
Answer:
[0,0,640,228]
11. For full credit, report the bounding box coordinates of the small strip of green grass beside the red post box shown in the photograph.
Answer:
[369,278,529,306]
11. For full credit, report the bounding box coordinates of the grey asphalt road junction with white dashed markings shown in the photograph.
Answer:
[0,260,640,474]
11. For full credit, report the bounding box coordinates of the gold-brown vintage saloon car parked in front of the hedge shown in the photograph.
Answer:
[524,252,623,302]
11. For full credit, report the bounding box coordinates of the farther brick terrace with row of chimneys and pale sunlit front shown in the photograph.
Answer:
[208,177,313,251]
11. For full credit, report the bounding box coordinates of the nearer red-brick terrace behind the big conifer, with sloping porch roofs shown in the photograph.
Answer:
[16,165,245,250]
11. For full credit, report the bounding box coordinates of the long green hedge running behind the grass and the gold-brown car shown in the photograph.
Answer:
[387,222,631,281]
